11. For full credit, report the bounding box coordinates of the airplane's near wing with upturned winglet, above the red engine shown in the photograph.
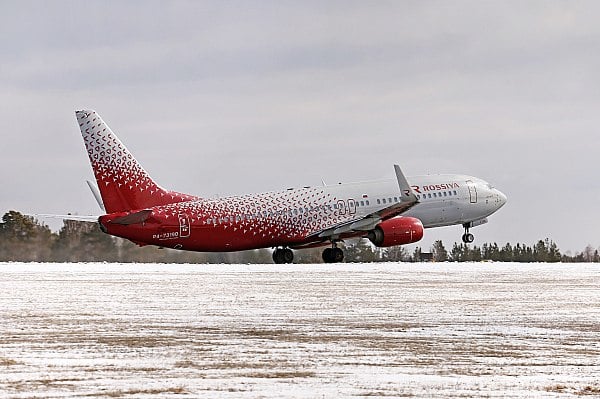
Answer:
[309,165,419,238]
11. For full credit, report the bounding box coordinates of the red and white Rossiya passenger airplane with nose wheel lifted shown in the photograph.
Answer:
[55,110,506,264]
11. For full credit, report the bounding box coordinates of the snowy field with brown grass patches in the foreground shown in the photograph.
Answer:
[0,263,600,398]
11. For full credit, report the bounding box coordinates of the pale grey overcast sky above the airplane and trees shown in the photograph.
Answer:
[0,1,600,252]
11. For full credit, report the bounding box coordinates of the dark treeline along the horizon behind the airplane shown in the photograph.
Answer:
[0,211,600,263]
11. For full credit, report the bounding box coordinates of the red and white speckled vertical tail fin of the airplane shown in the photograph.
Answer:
[75,110,196,213]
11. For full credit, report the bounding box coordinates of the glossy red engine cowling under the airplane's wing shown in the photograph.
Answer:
[367,216,423,247]
